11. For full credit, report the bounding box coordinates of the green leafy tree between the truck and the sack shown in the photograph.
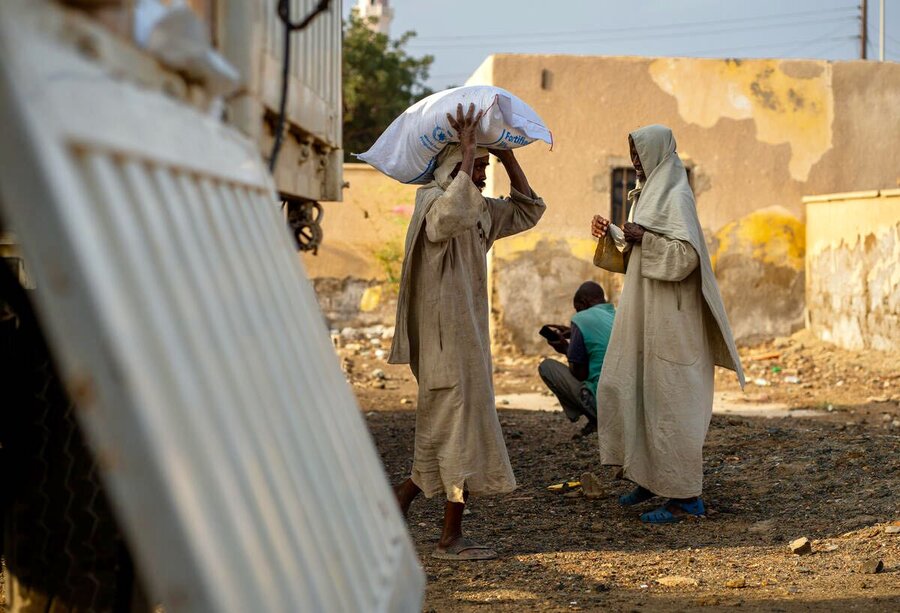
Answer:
[343,10,434,162]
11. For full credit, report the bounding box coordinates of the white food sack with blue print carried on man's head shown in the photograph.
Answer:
[356,85,553,185]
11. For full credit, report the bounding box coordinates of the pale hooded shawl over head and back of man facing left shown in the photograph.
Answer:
[630,125,744,387]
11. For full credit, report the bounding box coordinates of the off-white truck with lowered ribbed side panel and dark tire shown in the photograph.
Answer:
[0,0,424,613]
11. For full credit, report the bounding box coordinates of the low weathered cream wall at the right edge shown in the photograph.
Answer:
[803,189,900,351]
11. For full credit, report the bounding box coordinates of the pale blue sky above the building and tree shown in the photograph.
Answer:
[343,0,900,90]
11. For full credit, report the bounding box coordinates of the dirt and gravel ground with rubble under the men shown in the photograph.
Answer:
[338,330,900,612]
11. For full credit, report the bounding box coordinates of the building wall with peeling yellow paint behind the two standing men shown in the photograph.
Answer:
[469,55,900,351]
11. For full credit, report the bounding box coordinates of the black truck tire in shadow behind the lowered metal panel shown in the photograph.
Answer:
[0,263,146,613]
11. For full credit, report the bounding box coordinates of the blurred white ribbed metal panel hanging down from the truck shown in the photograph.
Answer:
[0,0,423,613]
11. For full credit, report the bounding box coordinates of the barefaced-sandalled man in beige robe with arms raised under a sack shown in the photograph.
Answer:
[388,105,545,560]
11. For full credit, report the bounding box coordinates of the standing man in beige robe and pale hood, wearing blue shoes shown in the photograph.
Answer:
[591,125,744,523]
